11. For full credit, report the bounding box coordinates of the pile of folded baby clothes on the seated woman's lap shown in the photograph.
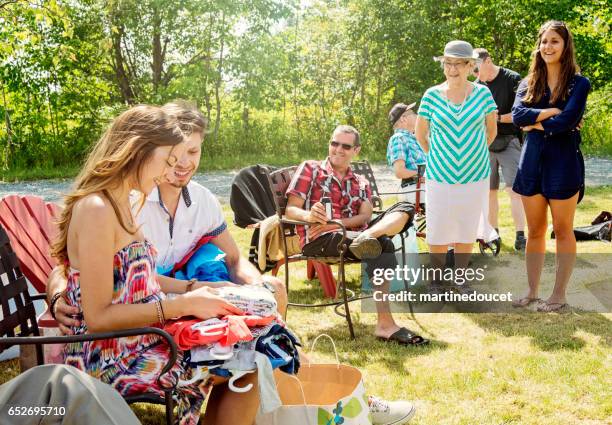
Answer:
[164,285,301,413]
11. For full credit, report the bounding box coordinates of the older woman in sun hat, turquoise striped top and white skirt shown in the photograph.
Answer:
[416,40,497,289]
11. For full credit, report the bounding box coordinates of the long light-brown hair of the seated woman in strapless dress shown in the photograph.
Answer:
[51,105,184,265]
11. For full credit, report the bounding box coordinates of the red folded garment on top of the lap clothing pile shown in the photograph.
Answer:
[164,315,276,350]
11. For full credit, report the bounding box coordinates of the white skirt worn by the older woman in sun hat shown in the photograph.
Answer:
[425,177,497,245]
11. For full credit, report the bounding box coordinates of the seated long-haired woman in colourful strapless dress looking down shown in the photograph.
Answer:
[53,105,252,425]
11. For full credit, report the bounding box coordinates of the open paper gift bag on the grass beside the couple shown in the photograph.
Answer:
[255,334,372,425]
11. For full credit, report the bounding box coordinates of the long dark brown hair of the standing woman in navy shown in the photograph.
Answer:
[524,21,580,104]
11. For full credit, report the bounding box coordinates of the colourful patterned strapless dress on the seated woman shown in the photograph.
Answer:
[64,241,210,425]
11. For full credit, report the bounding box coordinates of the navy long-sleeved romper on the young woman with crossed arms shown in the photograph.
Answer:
[512,75,591,202]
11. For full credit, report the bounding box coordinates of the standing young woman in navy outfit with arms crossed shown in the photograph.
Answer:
[512,21,590,312]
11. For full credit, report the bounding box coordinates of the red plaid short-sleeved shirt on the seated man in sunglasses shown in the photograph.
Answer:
[287,158,372,246]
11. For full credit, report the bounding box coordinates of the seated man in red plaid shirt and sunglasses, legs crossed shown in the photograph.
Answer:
[286,125,427,345]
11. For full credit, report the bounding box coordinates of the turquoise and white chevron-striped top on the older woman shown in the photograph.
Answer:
[418,84,497,184]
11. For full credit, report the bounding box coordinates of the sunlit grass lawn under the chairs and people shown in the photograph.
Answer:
[0,186,612,425]
